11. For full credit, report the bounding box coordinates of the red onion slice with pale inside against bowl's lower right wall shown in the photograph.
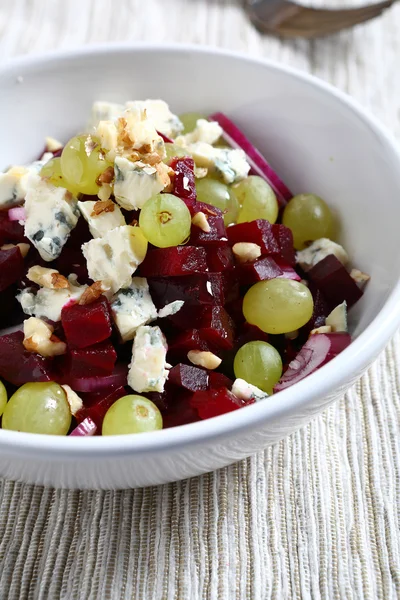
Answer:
[274,333,351,392]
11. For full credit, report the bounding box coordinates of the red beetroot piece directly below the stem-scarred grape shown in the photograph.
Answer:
[140,246,207,277]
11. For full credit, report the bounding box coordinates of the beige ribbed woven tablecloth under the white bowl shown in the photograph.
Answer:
[0,0,400,600]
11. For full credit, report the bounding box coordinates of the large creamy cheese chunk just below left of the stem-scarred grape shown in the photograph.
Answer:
[82,225,147,294]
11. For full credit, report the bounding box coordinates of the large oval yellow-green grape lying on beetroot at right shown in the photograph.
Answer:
[243,278,314,334]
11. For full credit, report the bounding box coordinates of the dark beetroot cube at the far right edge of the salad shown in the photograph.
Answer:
[307,254,363,309]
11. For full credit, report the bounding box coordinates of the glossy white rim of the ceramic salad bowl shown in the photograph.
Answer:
[0,42,400,460]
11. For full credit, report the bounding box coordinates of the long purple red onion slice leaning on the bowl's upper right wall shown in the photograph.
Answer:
[208,113,293,206]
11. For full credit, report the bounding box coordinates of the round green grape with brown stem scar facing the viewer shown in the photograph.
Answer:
[139,194,192,248]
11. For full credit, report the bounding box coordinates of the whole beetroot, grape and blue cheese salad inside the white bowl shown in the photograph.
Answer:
[0,100,369,436]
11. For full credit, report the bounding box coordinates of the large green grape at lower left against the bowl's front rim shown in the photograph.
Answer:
[2,381,71,435]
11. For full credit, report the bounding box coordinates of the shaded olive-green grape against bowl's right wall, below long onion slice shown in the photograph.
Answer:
[282,194,335,250]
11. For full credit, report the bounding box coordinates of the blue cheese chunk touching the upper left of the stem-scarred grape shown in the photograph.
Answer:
[114,156,169,210]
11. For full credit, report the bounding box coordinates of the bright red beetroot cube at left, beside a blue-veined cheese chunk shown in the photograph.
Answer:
[61,296,112,348]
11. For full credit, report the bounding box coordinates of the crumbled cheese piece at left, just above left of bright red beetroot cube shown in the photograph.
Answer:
[17,275,87,322]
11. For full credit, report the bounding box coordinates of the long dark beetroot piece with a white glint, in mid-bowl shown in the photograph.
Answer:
[148,272,239,308]
